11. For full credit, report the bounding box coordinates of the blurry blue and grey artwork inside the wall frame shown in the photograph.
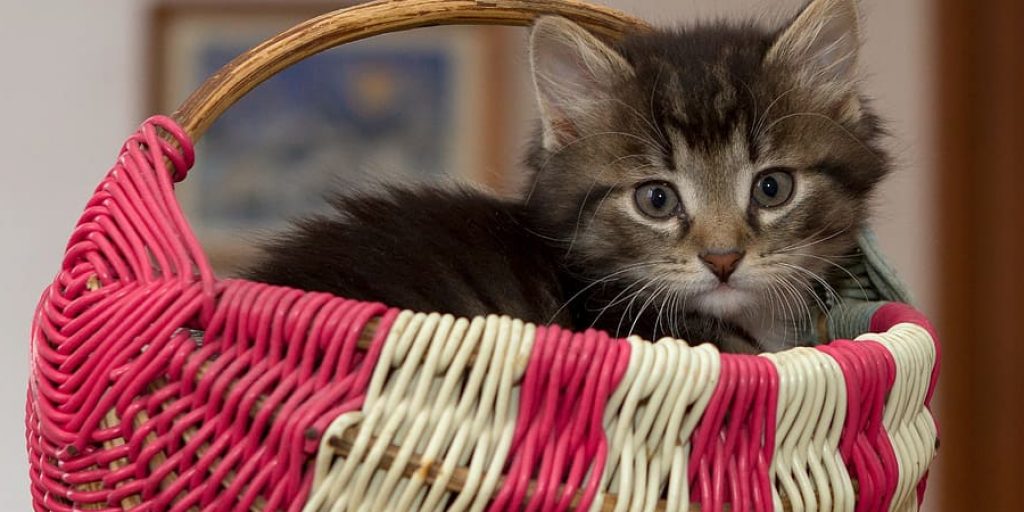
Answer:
[197,46,456,227]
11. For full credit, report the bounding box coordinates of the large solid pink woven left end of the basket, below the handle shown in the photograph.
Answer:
[26,118,397,511]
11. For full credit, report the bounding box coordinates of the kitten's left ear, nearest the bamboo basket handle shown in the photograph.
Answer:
[529,16,633,150]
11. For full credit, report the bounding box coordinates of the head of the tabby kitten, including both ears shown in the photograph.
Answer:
[529,0,887,344]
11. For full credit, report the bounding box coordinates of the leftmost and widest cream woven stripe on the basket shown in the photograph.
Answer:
[305,311,536,511]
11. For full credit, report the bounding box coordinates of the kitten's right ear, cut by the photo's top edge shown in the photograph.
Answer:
[768,0,860,82]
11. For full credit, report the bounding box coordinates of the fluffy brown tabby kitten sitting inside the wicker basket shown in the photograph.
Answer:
[248,0,888,352]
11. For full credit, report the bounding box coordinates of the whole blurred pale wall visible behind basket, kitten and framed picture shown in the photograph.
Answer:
[0,0,951,510]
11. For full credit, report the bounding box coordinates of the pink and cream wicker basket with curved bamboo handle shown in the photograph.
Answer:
[27,0,938,511]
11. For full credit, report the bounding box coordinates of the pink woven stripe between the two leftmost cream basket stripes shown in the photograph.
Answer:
[489,327,630,512]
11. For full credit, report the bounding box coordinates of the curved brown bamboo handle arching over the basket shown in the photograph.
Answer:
[167,0,647,142]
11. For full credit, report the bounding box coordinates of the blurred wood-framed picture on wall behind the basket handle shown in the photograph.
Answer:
[147,1,510,273]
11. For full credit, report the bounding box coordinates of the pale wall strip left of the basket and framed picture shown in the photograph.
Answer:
[0,0,141,505]
